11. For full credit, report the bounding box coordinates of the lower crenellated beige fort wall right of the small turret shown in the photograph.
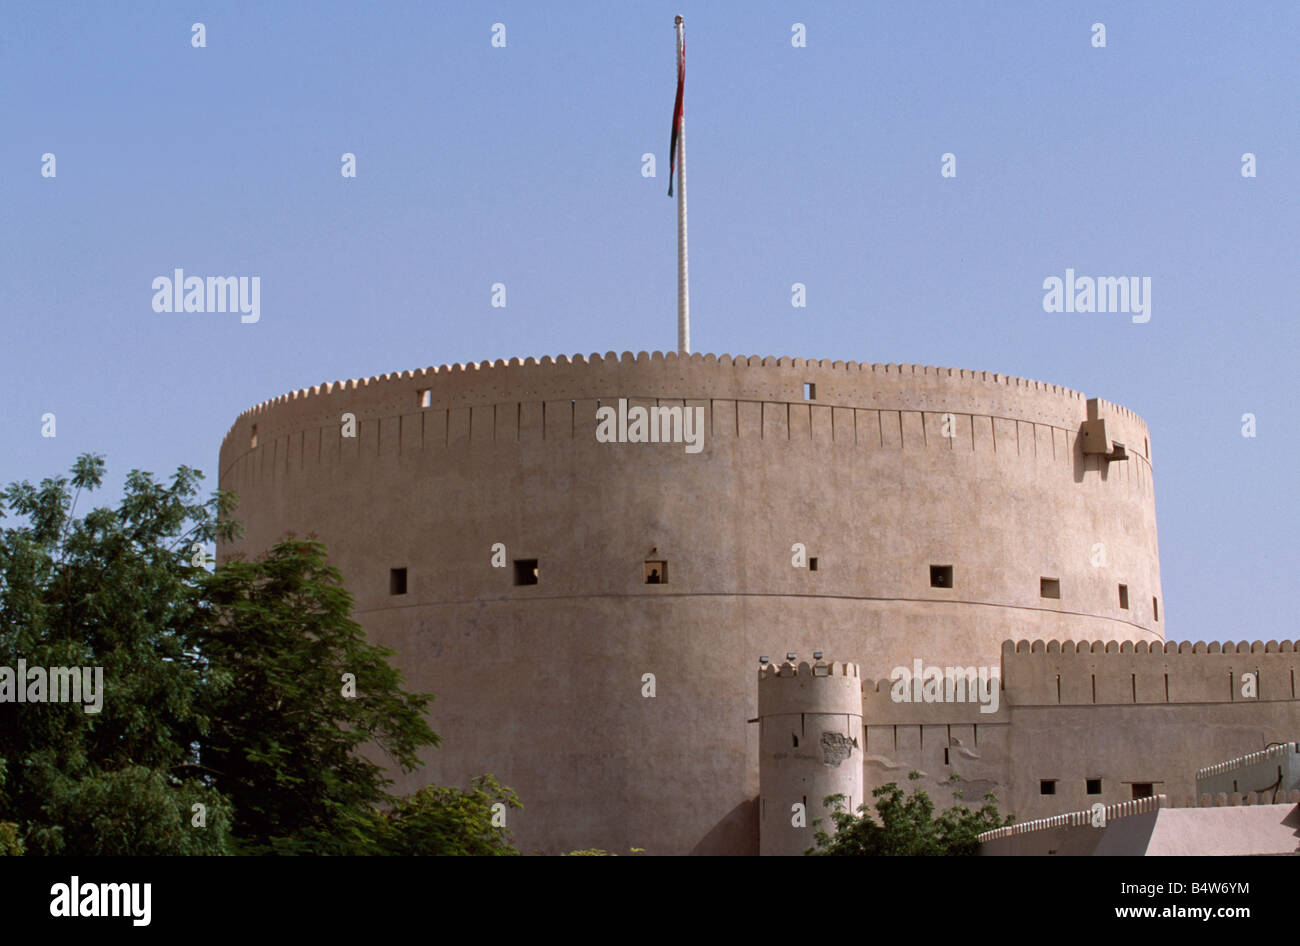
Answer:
[863,641,1300,820]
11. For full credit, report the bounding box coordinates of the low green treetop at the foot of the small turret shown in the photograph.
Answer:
[807,772,1015,856]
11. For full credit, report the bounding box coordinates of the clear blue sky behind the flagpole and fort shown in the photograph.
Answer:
[0,0,1300,641]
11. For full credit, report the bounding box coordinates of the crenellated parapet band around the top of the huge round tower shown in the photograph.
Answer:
[221,351,1151,489]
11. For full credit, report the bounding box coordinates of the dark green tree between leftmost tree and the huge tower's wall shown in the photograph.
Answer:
[196,539,439,854]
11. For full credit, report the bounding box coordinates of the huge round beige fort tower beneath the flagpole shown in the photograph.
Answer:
[218,352,1164,854]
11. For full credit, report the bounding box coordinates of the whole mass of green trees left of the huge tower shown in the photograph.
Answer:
[0,455,519,855]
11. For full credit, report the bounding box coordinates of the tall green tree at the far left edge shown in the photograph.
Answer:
[0,455,231,854]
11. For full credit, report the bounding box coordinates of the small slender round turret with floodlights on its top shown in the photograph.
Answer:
[758,652,863,855]
